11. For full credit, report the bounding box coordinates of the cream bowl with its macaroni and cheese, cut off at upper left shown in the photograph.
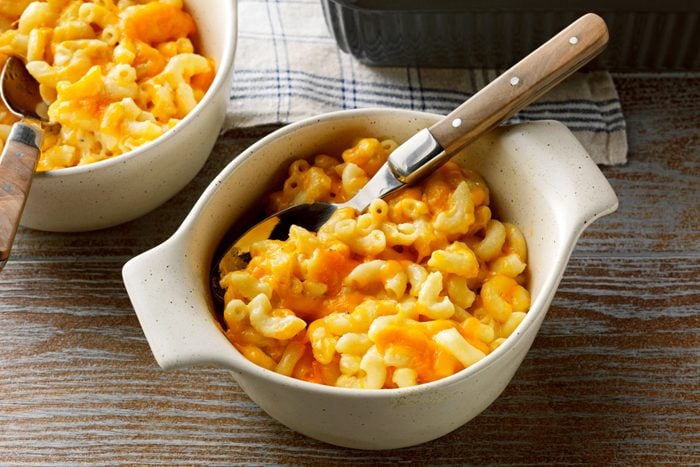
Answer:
[0,0,237,231]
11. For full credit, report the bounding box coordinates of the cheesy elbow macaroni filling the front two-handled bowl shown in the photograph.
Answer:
[219,138,530,389]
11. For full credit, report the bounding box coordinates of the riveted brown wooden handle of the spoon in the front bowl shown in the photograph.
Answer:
[429,13,608,155]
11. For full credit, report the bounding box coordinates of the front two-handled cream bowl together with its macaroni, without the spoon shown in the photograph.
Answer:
[123,109,617,449]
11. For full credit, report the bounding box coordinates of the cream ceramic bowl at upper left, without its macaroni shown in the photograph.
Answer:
[20,0,237,232]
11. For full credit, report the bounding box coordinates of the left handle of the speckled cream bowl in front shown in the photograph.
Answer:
[122,238,242,369]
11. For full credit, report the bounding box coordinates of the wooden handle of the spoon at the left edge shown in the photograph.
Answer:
[0,122,41,263]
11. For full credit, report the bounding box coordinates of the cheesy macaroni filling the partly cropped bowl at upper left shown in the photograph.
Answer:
[0,0,214,171]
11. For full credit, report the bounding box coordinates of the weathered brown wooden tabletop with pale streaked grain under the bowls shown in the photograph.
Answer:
[0,75,700,465]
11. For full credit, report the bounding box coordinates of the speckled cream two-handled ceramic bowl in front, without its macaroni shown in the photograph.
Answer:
[123,110,617,449]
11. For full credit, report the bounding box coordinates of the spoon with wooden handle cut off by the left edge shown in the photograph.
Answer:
[0,57,48,270]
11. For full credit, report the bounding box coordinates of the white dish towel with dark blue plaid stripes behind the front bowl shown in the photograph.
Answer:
[224,0,627,164]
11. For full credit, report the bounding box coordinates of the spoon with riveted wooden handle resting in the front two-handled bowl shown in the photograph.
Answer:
[211,13,608,300]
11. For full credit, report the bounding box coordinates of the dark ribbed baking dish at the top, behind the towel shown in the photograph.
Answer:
[321,0,700,71]
